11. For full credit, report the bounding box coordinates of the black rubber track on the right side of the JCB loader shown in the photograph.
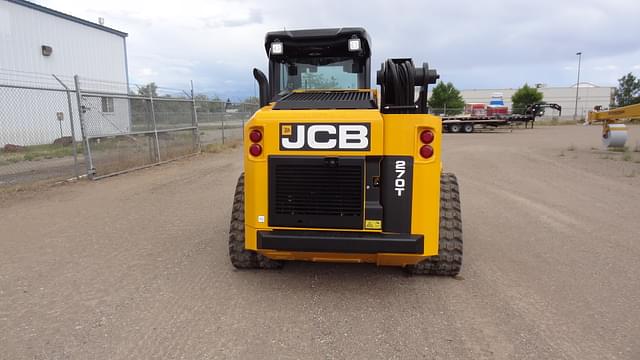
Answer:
[406,173,462,276]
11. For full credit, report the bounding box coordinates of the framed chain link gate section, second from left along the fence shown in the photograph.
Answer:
[76,78,200,179]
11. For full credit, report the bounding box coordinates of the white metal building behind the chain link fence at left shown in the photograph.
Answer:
[0,0,130,146]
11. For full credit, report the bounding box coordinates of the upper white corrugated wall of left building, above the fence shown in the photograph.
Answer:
[0,1,127,88]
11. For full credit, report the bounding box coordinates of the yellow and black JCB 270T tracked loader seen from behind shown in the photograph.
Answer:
[229,28,462,275]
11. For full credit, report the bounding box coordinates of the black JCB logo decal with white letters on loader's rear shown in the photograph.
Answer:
[280,123,371,151]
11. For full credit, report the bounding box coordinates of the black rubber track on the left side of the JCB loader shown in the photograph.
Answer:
[229,173,282,269]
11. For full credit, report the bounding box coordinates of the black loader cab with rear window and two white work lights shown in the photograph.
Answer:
[265,28,371,101]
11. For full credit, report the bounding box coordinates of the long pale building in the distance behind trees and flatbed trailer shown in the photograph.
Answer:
[460,82,614,118]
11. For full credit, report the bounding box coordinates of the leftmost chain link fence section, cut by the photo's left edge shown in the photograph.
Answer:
[0,69,85,186]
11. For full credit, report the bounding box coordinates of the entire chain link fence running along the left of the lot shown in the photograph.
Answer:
[0,69,259,186]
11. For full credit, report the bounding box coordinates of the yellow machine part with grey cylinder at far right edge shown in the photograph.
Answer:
[587,104,640,148]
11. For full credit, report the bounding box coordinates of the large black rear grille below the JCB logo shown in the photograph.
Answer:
[269,157,364,229]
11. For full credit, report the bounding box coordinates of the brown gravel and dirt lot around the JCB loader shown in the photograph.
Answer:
[0,126,640,359]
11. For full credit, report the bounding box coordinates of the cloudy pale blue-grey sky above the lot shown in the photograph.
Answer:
[36,0,640,100]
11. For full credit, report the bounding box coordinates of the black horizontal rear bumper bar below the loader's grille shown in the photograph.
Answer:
[258,230,424,254]
